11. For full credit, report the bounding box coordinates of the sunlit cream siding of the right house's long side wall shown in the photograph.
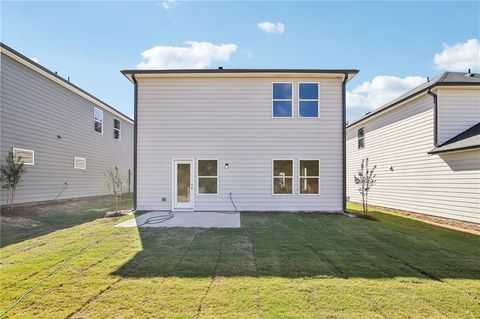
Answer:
[347,93,480,223]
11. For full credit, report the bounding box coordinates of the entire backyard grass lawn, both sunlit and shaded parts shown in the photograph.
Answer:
[0,202,480,318]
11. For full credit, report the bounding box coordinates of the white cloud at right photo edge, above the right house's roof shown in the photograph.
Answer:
[433,39,480,72]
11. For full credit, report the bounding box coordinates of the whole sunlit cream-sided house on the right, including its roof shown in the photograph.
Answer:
[347,72,480,223]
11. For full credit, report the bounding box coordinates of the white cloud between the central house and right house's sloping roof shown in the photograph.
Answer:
[347,75,427,110]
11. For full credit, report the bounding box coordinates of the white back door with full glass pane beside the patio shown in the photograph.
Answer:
[173,160,194,210]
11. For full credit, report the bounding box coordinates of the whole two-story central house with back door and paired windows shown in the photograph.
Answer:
[122,68,358,212]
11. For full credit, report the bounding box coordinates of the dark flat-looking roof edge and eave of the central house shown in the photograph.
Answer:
[121,68,359,82]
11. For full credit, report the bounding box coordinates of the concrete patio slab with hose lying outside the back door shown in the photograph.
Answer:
[115,211,241,228]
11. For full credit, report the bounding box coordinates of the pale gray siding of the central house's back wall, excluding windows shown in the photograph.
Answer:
[137,77,343,211]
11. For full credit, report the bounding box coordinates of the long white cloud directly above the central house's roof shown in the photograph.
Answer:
[137,41,238,69]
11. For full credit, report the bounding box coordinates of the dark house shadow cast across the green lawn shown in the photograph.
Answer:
[113,211,480,281]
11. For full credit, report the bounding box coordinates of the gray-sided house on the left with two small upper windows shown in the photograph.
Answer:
[0,44,133,205]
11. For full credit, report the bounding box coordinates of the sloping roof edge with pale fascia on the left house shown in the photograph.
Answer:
[0,42,133,124]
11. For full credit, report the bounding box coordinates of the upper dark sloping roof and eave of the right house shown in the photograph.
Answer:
[347,72,480,128]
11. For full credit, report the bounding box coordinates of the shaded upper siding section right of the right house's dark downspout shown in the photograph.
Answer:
[438,88,480,144]
